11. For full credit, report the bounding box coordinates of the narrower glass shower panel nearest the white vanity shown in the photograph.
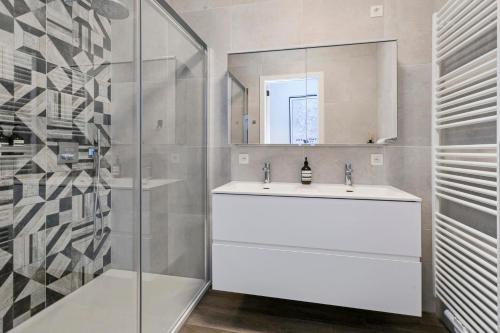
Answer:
[141,0,207,333]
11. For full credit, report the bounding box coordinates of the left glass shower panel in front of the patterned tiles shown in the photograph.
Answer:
[0,0,140,333]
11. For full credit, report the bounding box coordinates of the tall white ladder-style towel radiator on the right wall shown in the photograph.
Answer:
[432,0,500,333]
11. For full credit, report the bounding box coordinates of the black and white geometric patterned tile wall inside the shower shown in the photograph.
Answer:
[0,0,111,332]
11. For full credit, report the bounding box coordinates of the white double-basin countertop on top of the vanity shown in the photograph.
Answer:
[212,181,422,202]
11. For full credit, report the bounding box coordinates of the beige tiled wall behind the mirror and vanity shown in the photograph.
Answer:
[169,0,444,311]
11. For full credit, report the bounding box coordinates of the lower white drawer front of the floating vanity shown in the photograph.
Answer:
[212,243,422,316]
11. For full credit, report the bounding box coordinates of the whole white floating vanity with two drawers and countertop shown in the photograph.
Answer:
[212,182,422,316]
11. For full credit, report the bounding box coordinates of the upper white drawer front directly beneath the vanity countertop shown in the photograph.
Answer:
[212,194,421,257]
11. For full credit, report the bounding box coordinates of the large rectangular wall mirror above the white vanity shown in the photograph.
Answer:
[227,41,397,145]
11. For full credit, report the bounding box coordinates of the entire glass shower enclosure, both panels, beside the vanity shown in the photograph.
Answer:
[0,0,209,333]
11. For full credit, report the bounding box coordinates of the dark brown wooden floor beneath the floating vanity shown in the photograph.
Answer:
[181,291,448,333]
